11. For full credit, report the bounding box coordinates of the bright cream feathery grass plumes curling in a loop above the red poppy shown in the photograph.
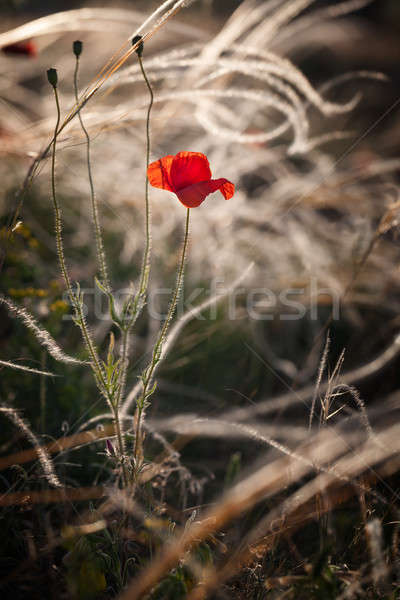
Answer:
[101,40,359,153]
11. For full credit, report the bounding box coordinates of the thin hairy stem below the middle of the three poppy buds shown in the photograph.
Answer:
[74,56,110,291]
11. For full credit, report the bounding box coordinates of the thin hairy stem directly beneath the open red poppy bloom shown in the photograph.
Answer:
[134,208,190,460]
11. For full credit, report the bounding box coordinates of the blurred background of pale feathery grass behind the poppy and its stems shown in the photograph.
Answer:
[0,0,400,597]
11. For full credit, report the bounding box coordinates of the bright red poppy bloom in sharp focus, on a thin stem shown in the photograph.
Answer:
[147,152,235,208]
